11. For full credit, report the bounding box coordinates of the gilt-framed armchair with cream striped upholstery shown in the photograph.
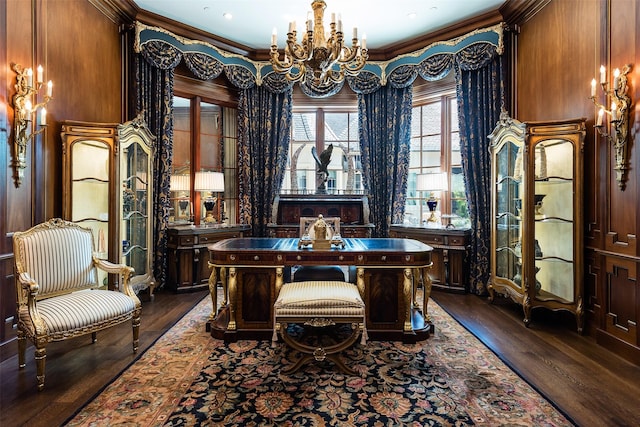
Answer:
[13,218,141,390]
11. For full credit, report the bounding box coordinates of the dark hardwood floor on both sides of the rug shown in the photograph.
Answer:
[0,291,640,427]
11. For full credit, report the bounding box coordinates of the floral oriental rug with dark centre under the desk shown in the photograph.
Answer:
[66,298,573,427]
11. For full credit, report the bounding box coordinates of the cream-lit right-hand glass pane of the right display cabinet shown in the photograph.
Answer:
[531,139,576,303]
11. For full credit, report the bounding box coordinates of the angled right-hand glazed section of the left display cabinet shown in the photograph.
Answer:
[117,116,155,298]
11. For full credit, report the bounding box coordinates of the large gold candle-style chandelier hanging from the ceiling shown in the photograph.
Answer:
[271,0,369,87]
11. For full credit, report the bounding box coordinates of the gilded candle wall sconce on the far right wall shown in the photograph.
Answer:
[591,64,631,190]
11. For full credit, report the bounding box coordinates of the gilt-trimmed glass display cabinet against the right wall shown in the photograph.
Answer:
[488,112,585,332]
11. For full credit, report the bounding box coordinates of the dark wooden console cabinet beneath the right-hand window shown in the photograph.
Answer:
[389,225,471,293]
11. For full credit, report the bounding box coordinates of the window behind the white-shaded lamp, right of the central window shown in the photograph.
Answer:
[404,88,469,227]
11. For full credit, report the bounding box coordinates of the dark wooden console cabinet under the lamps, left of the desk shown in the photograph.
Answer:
[166,224,251,292]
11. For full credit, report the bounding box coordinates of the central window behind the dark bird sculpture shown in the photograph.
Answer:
[281,109,364,194]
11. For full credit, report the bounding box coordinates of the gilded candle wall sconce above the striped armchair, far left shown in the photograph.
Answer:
[11,64,53,187]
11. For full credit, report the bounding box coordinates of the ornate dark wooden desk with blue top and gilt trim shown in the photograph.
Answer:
[208,237,432,343]
